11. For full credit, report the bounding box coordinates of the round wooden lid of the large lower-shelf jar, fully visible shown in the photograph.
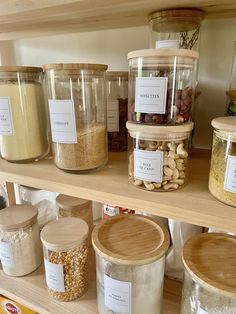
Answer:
[92,215,170,265]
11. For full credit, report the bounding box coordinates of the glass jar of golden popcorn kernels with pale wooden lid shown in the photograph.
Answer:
[41,217,88,301]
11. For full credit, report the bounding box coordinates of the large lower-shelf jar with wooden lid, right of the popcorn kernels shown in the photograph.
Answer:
[92,215,169,314]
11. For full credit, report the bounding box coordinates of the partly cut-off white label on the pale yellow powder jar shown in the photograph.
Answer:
[0,97,14,135]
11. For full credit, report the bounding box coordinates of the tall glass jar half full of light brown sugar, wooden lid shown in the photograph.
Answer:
[44,63,107,172]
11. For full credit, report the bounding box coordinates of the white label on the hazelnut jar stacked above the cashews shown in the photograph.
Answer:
[135,77,168,114]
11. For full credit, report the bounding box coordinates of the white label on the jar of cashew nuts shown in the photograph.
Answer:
[134,149,163,182]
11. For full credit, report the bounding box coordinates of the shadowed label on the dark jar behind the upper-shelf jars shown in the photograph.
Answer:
[107,100,119,132]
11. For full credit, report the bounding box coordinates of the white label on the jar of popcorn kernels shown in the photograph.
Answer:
[44,259,65,292]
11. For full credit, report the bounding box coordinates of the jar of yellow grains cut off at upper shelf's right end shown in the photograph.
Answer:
[209,117,236,207]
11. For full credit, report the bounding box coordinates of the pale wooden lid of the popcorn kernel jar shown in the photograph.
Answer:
[41,217,88,252]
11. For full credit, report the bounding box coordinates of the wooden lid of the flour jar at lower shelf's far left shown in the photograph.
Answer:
[0,205,38,231]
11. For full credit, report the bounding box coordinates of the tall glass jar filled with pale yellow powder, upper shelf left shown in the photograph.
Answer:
[0,66,49,163]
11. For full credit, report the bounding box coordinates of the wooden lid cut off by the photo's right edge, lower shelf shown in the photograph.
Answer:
[183,233,236,298]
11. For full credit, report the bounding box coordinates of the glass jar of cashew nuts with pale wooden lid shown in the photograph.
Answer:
[126,122,194,191]
